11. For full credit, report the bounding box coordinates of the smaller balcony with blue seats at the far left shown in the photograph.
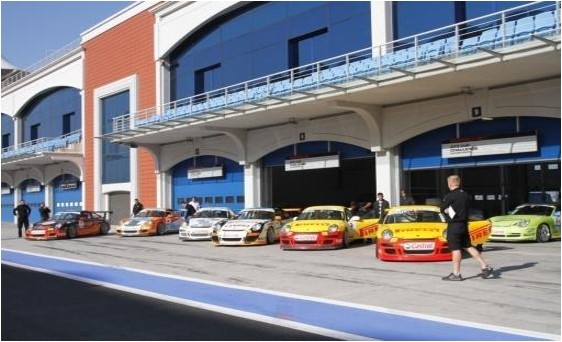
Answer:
[2,130,82,170]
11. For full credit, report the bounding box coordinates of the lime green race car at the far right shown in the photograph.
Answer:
[488,203,560,242]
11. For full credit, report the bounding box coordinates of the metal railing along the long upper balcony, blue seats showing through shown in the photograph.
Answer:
[105,2,560,139]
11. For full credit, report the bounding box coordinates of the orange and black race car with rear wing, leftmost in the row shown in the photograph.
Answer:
[25,210,111,240]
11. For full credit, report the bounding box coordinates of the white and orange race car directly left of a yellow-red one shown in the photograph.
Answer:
[212,208,281,245]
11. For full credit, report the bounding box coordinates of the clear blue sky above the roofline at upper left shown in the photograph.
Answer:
[0,0,133,68]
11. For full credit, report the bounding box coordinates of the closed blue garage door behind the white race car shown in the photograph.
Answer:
[172,156,244,211]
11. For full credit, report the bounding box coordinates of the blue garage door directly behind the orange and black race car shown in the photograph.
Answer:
[51,174,82,215]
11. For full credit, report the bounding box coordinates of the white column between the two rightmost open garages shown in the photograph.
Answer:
[375,148,400,206]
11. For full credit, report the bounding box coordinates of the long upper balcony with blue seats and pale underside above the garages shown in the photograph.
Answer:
[102,2,560,144]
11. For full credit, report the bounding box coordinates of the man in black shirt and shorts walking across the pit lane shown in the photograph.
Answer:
[441,175,493,281]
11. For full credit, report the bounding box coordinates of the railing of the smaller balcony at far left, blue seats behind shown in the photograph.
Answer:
[2,130,82,162]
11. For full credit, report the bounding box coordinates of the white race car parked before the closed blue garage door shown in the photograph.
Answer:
[179,207,236,241]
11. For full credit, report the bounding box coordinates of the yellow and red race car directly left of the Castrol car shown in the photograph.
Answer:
[280,205,374,249]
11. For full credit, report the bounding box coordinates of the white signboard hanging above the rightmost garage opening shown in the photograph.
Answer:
[441,132,538,158]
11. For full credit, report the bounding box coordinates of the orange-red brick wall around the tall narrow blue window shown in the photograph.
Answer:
[83,11,156,209]
